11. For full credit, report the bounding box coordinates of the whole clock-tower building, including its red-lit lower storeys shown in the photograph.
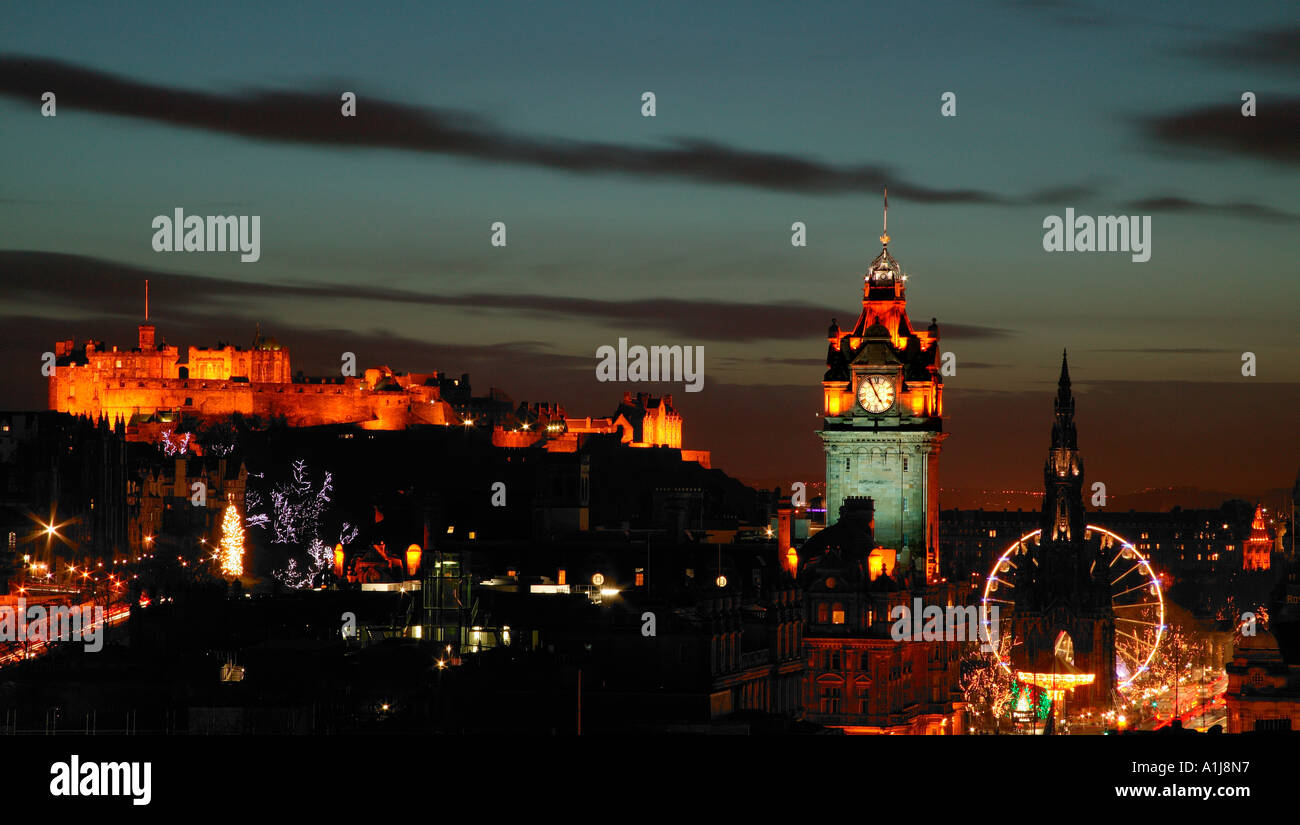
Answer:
[776,200,963,734]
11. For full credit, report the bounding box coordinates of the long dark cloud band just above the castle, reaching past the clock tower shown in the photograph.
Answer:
[0,251,1011,343]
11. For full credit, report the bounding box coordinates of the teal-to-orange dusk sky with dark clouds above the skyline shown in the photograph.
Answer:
[0,0,1300,504]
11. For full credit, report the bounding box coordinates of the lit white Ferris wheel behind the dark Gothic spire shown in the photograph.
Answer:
[980,525,1165,690]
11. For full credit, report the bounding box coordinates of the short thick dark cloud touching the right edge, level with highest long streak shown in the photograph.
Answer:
[1140,97,1300,165]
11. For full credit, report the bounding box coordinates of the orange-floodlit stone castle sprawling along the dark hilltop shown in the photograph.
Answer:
[48,299,710,468]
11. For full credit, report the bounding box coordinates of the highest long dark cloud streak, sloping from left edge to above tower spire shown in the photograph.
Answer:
[0,56,1092,205]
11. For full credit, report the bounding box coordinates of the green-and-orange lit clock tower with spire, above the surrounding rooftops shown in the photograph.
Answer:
[818,192,946,582]
